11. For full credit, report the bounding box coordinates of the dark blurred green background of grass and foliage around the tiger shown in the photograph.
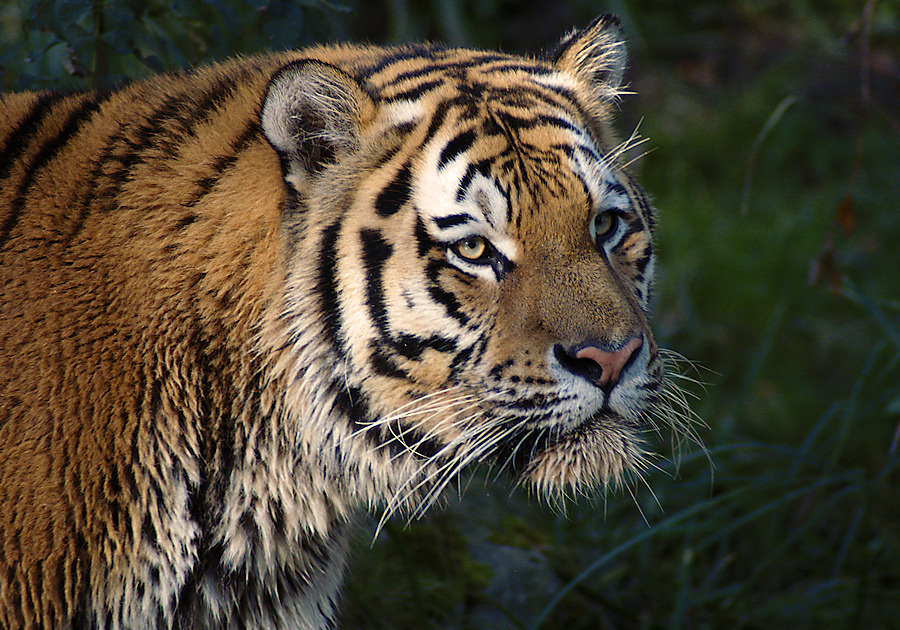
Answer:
[0,0,900,630]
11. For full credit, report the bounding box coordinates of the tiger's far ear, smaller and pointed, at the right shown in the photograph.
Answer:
[547,15,628,101]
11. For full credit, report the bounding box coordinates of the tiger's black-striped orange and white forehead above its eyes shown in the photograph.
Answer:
[382,68,621,259]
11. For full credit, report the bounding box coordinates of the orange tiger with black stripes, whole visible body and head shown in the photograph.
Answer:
[0,16,688,629]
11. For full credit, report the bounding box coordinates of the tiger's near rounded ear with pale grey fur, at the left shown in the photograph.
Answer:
[260,60,375,190]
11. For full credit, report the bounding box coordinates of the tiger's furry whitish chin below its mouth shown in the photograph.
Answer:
[518,414,647,499]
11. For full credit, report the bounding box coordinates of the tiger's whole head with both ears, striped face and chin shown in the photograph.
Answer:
[261,17,684,520]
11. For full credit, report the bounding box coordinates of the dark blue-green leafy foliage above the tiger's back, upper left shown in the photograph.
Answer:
[0,0,347,89]
